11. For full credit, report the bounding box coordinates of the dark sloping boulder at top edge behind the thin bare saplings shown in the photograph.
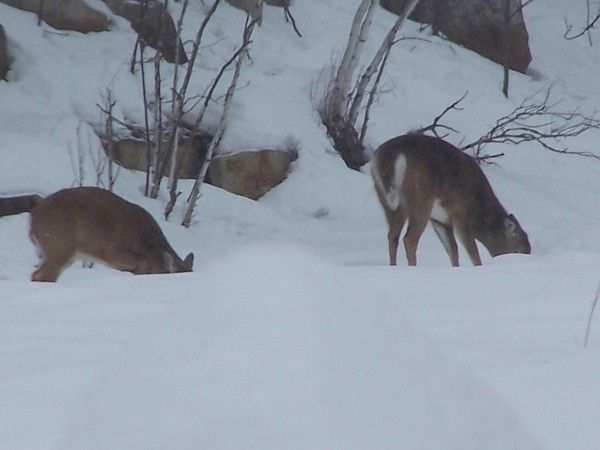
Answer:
[104,0,188,64]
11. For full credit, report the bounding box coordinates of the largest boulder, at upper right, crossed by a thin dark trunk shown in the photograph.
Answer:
[380,0,531,72]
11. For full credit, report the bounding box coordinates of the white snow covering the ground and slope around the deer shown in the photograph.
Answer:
[0,0,600,450]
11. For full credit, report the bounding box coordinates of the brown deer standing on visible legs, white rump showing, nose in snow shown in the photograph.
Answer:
[371,133,531,266]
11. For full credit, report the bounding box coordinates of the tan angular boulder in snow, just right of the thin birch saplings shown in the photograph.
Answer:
[208,150,298,200]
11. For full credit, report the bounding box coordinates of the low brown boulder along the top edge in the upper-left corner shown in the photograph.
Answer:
[0,0,109,33]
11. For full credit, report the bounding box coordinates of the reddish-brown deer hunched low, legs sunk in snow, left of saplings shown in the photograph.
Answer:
[0,187,194,281]
